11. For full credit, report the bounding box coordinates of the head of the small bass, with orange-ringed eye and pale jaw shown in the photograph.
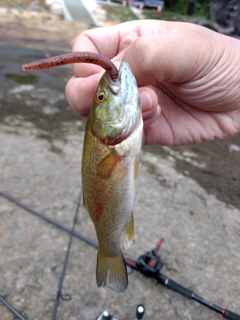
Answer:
[88,62,141,145]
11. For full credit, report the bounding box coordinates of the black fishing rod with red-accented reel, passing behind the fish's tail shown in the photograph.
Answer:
[0,192,240,320]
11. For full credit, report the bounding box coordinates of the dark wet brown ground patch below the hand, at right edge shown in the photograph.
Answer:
[145,135,240,208]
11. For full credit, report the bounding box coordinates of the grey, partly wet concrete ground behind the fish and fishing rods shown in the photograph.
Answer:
[0,5,240,320]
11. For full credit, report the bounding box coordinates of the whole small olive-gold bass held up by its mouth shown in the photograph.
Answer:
[82,61,143,293]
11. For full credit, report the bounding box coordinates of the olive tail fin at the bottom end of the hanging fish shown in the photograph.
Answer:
[96,250,128,292]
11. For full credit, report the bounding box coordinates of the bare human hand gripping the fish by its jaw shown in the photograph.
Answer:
[66,20,240,146]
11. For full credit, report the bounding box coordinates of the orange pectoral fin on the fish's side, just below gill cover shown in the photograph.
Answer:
[97,151,124,179]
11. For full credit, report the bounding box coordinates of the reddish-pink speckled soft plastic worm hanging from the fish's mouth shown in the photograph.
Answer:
[22,51,118,81]
